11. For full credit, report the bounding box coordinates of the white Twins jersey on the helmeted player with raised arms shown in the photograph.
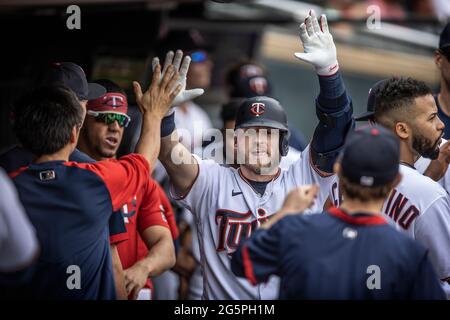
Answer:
[172,147,335,299]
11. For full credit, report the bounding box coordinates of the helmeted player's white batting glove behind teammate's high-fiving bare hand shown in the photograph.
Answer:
[152,50,205,115]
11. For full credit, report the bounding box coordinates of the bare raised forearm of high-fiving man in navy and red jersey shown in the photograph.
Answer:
[136,112,161,168]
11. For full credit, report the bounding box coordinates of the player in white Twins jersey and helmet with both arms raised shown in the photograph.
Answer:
[156,12,354,299]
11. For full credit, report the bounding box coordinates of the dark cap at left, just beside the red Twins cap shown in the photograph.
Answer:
[42,62,106,100]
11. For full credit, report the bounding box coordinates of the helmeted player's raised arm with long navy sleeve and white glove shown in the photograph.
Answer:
[295,11,354,173]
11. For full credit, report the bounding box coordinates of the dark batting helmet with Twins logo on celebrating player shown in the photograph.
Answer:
[235,96,289,131]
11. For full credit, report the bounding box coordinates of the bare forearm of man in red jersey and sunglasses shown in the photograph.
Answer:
[138,230,176,277]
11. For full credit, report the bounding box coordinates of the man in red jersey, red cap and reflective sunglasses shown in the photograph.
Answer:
[78,80,177,299]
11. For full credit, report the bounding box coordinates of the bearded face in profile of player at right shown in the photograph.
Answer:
[411,95,445,159]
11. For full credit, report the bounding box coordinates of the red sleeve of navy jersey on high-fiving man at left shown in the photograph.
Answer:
[66,154,150,211]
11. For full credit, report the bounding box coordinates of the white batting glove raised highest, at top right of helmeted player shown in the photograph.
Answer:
[295,10,339,76]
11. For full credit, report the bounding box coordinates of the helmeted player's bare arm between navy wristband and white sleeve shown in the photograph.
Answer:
[159,131,198,195]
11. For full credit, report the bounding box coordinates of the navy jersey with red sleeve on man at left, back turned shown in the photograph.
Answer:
[6,155,149,299]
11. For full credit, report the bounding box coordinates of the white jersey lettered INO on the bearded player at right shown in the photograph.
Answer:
[382,164,450,296]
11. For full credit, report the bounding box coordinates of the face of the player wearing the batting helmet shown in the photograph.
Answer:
[237,127,280,174]
